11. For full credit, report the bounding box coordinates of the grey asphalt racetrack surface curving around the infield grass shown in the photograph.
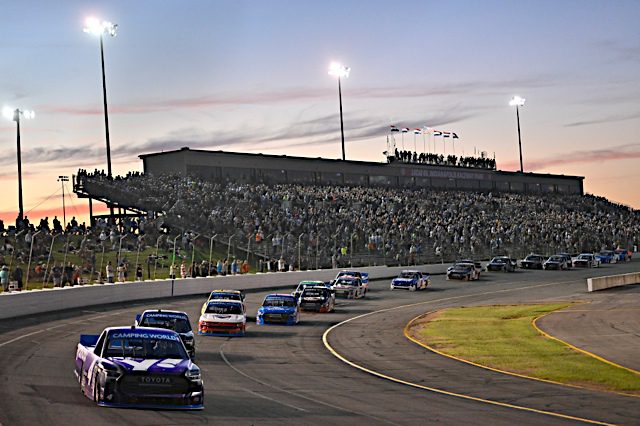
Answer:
[0,259,640,426]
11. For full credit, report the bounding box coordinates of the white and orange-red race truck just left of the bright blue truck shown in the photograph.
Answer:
[198,299,247,336]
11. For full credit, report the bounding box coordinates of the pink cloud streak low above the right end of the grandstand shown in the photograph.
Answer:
[499,143,640,171]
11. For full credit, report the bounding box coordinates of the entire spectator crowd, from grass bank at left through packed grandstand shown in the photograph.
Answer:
[0,170,640,290]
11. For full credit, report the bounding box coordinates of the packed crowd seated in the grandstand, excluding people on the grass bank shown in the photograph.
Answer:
[74,168,640,264]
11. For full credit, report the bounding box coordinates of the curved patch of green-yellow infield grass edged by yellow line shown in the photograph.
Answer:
[410,303,640,394]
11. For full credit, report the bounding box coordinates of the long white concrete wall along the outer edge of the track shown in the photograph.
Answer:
[0,264,447,318]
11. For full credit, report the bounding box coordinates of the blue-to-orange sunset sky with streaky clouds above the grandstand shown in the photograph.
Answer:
[0,0,640,225]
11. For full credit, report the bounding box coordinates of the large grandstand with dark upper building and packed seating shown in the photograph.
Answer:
[74,148,640,269]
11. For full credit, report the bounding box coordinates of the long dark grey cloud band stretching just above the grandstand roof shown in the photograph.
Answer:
[0,105,475,169]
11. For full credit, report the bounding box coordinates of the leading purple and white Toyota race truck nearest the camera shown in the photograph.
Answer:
[75,326,204,410]
